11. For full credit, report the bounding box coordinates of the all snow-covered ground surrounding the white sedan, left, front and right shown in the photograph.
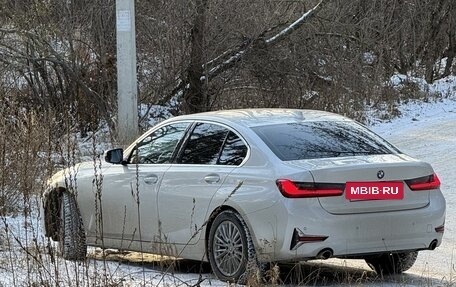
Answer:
[0,76,456,287]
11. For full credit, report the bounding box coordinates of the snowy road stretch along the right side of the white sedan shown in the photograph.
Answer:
[371,93,456,284]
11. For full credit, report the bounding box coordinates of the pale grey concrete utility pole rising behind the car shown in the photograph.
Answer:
[116,0,138,146]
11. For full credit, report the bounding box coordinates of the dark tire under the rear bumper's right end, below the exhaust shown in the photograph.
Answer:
[365,251,418,275]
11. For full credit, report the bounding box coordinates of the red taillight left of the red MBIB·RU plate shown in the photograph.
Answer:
[276,179,345,198]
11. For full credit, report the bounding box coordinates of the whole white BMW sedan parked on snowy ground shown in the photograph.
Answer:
[43,109,446,283]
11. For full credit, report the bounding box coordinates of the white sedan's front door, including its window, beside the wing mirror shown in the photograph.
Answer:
[84,122,190,246]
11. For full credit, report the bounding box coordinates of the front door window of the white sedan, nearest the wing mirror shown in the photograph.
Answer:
[129,123,189,164]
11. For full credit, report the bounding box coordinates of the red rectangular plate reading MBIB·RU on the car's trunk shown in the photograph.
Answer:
[345,181,404,201]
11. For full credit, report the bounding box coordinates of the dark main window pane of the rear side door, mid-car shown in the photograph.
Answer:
[180,123,229,164]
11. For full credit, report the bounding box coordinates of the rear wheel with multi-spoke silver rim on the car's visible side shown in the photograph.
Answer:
[207,210,261,284]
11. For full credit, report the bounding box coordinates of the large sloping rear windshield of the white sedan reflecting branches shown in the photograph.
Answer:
[252,121,399,161]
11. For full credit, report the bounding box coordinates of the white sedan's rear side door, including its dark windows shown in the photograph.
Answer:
[158,123,247,244]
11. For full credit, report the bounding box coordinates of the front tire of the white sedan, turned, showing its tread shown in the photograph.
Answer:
[59,192,87,260]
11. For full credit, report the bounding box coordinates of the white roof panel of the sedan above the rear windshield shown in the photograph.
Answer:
[166,109,351,127]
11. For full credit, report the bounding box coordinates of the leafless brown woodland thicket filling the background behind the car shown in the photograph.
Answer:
[0,0,456,142]
